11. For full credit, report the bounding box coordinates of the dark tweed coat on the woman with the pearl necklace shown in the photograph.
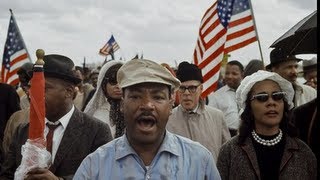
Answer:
[217,136,317,180]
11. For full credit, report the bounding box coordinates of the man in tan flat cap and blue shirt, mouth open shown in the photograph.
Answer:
[74,59,220,180]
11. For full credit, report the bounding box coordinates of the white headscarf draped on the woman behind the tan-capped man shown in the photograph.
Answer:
[84,60,124,116]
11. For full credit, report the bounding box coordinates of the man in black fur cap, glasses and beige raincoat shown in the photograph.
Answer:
[167,62,230,160]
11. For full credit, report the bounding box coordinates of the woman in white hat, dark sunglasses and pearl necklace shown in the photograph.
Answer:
[217,70,317,180]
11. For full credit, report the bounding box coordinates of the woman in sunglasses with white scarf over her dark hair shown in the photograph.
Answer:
[84,60,125,138]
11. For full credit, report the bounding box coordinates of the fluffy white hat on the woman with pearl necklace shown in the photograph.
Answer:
[236,70,294,115]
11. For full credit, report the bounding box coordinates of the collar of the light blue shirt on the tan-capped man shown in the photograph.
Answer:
[115,131,180,160]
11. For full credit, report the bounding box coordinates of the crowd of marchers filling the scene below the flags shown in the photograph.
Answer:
[0,48,320,180]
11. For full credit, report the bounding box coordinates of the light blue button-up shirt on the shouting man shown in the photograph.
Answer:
[74,131,221,180]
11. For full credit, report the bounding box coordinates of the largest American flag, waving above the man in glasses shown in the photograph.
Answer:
[193,0,257,97]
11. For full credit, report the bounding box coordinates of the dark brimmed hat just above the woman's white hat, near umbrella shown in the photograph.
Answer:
[266,48,302,70]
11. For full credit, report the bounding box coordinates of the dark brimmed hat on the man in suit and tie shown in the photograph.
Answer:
[43,54,81,84]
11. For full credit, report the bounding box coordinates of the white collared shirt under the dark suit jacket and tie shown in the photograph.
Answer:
[44,106,74,164]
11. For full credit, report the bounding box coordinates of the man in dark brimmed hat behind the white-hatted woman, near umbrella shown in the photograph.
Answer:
[266,48,317,107]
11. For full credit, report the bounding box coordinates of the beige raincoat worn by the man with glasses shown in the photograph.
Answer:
[166,105,230,161]
